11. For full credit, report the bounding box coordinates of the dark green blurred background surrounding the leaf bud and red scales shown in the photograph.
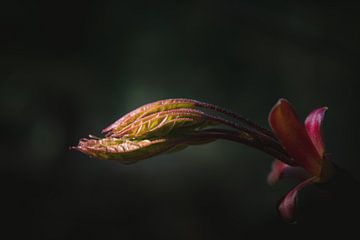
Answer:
[0,0,360,239]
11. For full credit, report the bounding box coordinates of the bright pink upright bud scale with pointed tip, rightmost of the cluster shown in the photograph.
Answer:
[305,107,327,157]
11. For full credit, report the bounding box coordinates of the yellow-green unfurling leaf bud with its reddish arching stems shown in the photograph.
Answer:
[73,99,291,163]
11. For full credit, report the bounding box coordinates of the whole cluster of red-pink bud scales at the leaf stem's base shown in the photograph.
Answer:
[268,99,334,221]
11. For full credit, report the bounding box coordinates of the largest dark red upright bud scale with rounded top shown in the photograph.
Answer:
[269,99,321,176]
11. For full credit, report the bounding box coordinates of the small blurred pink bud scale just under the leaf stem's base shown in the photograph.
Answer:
[267,159,309,185]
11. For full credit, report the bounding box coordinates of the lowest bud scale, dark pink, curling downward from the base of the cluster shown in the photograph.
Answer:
[278,177,317,222]
